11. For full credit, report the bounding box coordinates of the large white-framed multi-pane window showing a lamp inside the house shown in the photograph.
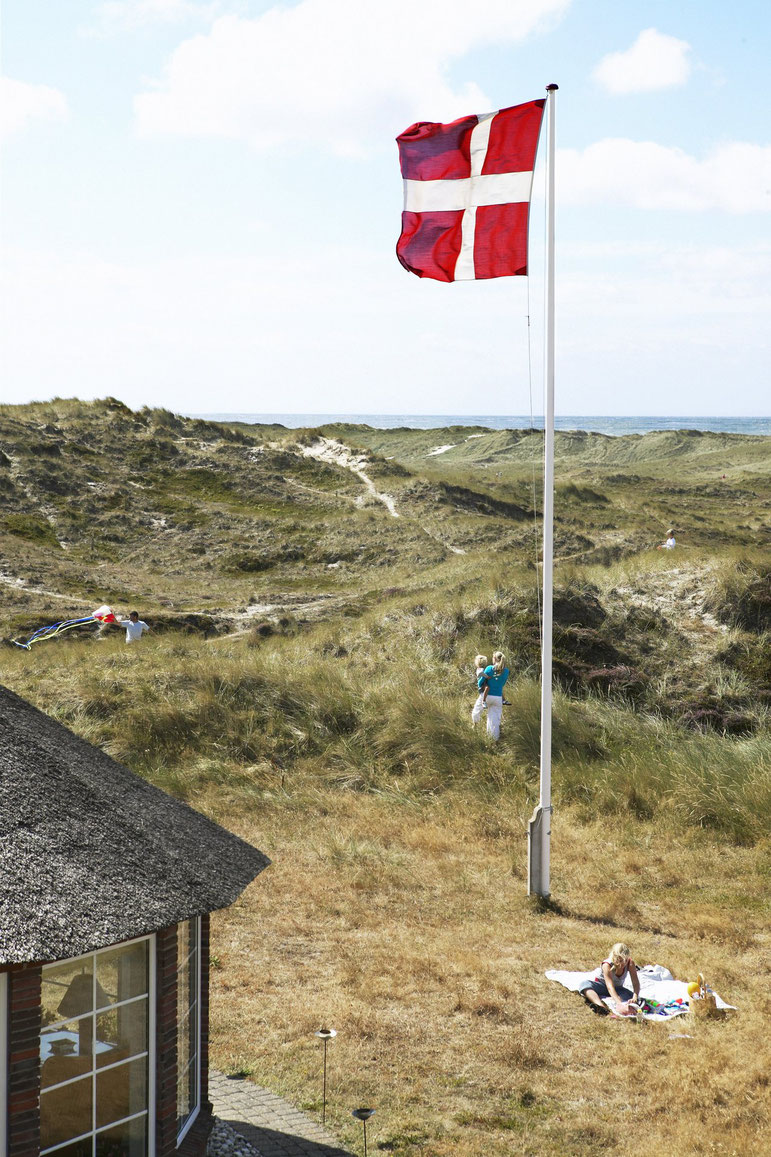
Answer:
[41,937,154,1157]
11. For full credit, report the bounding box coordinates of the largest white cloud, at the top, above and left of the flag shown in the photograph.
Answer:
[134,0,571,154]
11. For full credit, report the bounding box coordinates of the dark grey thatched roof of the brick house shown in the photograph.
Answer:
[0,687,270,964]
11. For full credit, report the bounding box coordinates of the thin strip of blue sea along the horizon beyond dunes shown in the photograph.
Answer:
[190,414,771,437]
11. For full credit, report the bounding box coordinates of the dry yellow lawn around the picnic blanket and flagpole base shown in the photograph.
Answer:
[206,789,771,1157]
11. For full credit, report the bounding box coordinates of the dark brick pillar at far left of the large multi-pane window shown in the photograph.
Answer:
[8,965,42,1157]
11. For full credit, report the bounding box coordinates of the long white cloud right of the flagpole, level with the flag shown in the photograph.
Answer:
[557,138,771,213]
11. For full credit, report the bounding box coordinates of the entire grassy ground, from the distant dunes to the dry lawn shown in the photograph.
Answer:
[0,403,771,1157]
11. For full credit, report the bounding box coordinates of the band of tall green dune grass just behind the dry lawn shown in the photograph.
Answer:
[8,614,771,842]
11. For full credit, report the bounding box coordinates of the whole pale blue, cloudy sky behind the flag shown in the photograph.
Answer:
[0,0,771,415]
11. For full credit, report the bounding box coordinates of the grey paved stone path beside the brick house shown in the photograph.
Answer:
[208,1070,353,1157]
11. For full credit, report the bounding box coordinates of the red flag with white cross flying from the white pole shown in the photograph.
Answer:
[396,101,545,281]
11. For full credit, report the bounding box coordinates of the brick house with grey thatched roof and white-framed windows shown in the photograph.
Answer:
[0,688,269,1157]
